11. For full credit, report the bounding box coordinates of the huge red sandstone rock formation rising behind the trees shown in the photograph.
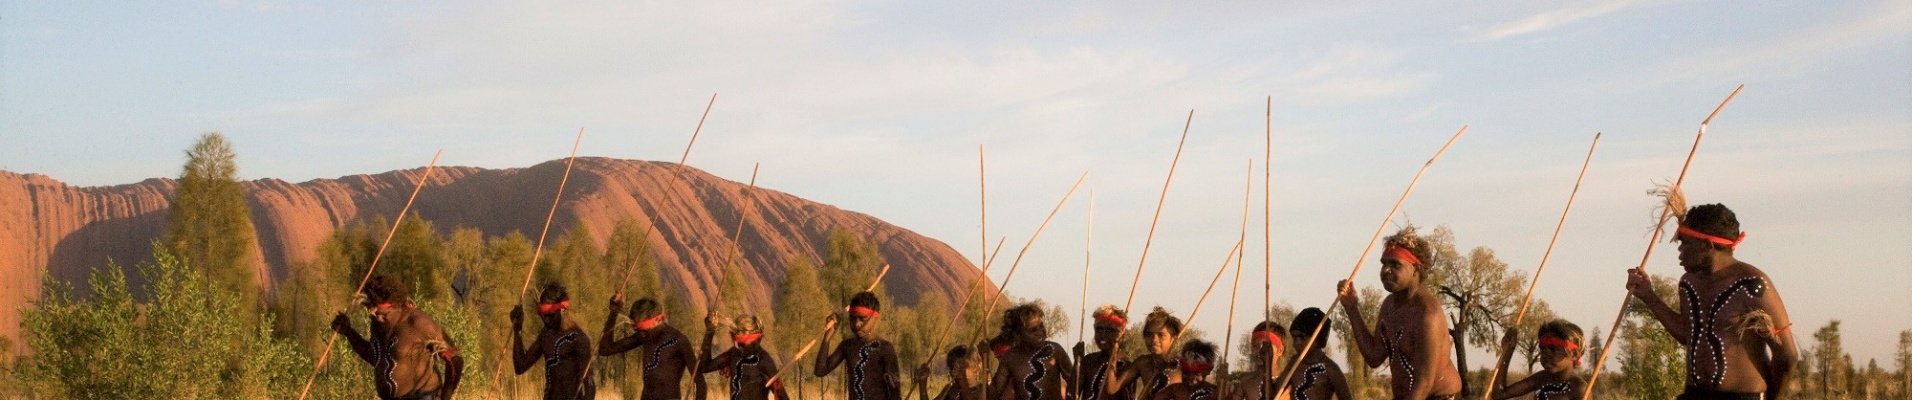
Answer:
[0,157,979,354]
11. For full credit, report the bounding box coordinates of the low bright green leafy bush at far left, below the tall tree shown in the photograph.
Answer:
[19,245,310,398]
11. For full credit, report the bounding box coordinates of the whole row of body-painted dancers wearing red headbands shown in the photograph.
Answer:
[333,205,1797,400]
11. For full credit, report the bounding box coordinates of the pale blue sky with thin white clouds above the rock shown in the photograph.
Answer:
[0,0,1912,367]
